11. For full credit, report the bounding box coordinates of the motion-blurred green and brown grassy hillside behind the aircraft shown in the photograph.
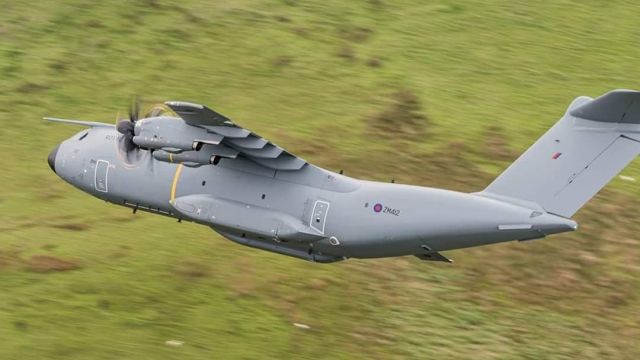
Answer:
[0,0,640,359]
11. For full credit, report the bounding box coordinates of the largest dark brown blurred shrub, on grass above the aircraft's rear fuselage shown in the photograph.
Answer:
[366,89,428,138]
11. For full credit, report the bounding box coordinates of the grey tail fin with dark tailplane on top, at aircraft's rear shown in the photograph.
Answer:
[482,90,640,217]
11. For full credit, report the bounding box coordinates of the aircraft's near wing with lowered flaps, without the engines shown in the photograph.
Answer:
[165,101,307,170]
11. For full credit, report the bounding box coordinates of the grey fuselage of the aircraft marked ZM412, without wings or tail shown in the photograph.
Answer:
[49,126,576,262]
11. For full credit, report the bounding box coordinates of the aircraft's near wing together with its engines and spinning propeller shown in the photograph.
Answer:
[116,101,306,170]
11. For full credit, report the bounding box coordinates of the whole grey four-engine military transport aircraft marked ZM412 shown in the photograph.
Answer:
[45,90,640,262]
